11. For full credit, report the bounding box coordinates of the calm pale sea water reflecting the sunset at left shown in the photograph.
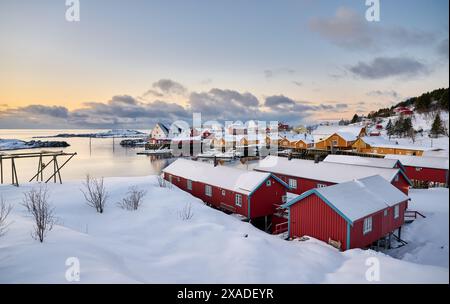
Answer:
[0,129,173,183]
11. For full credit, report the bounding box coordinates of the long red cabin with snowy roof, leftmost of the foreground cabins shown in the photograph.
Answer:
[163,159,289,219]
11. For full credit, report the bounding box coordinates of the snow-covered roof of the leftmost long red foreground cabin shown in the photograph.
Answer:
[163,158,270,195]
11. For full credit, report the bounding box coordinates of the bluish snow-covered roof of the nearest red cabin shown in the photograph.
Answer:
[315,176,409,222]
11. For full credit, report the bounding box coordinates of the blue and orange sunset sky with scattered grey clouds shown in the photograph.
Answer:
[0,0,449,129]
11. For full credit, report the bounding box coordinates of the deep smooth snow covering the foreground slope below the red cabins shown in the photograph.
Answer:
[0,176,449,283]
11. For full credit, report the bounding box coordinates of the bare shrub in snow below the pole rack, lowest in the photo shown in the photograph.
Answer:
[23,186,56,243]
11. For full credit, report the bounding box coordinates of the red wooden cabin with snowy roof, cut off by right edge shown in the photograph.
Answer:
[385,154,449,187]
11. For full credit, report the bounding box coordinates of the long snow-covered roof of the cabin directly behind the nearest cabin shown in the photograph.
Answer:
[255,156,400,183]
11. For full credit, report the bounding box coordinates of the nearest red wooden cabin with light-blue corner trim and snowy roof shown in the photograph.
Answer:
[284,176,409,250]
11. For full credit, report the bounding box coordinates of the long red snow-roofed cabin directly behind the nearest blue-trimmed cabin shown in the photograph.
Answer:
[255,156,412,195]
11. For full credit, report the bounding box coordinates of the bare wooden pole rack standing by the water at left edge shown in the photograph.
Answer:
[0,151,77,187]
